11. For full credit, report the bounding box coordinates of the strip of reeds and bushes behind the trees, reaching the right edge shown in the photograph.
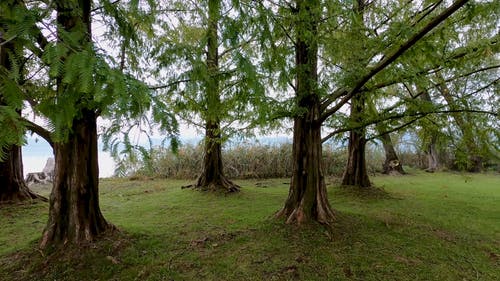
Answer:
[115,140,499,179]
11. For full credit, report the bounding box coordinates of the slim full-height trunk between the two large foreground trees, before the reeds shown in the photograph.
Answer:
[195,0,240,192]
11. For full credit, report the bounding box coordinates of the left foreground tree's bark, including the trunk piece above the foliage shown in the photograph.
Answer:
[41,0,113,248]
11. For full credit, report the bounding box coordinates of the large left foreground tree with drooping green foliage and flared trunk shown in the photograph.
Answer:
[0,0,176,247]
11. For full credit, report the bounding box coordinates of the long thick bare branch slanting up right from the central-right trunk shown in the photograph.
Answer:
[319,0,469,122]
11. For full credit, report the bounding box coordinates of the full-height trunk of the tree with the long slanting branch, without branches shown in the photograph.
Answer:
[276,0,335,225]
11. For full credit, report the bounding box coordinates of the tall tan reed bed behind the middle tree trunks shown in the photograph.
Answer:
[121,142,394,179]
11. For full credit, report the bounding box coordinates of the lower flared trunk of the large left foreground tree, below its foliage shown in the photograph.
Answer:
[41,111,113,248]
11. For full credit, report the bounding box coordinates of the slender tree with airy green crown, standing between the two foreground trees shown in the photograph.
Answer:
[155,0,264,192]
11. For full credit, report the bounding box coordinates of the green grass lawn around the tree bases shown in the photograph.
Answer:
[0,173,500,280]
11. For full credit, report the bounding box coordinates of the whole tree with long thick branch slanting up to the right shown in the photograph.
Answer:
[269,0,468,224]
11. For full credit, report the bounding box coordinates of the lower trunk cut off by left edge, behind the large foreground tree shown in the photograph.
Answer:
[0,145,47,204]
